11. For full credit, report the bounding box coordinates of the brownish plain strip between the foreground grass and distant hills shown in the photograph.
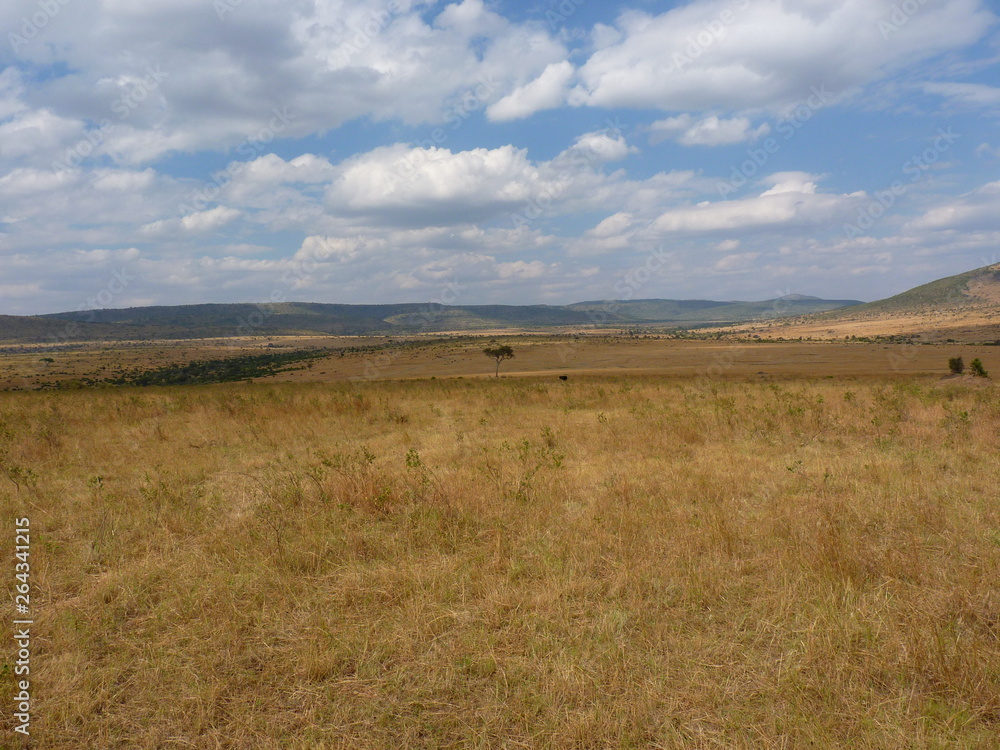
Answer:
[0,333,1000,389]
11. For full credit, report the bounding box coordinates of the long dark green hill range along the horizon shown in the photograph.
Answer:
[0,295,861,343]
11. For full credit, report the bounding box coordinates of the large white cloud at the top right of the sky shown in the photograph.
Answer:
[570,0,995,113]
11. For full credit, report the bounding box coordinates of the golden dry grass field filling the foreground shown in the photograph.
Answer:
[0,374,1000,750]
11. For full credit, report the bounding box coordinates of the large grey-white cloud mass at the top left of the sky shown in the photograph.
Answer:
[0,0,572,165]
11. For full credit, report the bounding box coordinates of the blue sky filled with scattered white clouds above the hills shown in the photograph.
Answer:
[0,0,1000,315]
